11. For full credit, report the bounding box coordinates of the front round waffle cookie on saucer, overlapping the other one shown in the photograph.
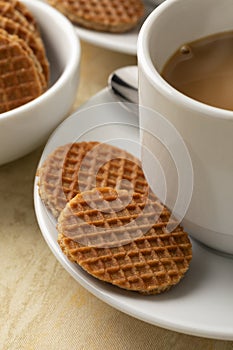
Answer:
[57,188,192,294]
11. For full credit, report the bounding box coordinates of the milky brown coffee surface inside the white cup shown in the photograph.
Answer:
[161,31,233,111]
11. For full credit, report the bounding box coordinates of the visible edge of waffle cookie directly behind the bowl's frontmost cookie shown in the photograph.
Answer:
[0,16,49,84]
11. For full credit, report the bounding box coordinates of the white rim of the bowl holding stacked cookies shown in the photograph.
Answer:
[0,0,81,121]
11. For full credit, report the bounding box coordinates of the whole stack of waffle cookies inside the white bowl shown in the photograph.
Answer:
[0,0,50,113]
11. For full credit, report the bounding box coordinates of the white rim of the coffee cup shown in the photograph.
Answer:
[137,0,233,120]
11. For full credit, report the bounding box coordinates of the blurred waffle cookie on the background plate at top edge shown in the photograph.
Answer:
[48,0,144,33]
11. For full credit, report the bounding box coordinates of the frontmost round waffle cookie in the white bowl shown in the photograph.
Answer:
[0,29,44,113]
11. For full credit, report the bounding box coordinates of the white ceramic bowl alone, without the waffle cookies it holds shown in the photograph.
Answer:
[0,0,80,164]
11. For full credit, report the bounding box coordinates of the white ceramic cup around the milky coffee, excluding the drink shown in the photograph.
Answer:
[137,0,233,254]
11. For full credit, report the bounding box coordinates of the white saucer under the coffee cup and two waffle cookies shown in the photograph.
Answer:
[34,89,233,340]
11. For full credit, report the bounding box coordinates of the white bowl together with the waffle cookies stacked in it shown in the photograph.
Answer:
[0,0,81,165]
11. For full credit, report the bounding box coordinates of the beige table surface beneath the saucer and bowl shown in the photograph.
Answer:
[0,42,233,350]
